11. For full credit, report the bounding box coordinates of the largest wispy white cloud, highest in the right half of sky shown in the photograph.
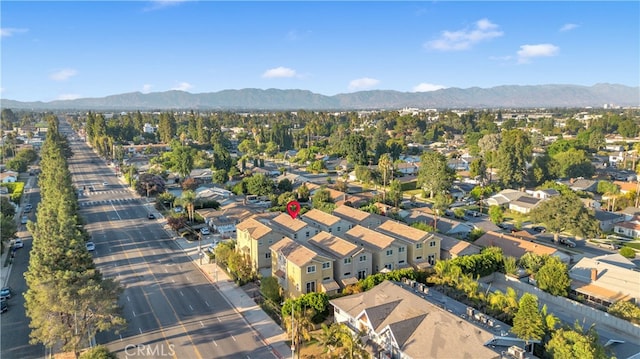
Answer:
[424,19,504,51]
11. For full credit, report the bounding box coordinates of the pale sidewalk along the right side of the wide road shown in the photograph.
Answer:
[170,232,291,359]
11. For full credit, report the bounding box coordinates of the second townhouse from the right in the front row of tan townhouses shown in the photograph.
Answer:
[344,225,409,273]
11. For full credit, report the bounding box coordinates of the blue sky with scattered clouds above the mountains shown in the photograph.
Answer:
[0,0,640,101]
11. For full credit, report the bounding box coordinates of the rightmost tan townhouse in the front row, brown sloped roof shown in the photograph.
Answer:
[376,220,440,269]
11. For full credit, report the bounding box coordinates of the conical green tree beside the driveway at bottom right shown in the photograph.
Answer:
[511,293,544,343]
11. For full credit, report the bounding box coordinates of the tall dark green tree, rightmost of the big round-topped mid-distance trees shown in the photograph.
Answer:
[497,129,533,188]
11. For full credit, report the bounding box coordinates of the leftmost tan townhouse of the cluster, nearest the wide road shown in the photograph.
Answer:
[236,215,285,275]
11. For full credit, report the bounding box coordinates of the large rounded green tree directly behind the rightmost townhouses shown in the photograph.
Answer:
[417,151,455,198]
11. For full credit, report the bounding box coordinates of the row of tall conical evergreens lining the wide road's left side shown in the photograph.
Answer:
[25,116,126,357]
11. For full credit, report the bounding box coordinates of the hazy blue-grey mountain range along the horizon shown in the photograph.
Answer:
[0,84,640,111]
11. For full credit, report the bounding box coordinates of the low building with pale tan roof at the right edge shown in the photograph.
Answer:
[569,254,640,307]
